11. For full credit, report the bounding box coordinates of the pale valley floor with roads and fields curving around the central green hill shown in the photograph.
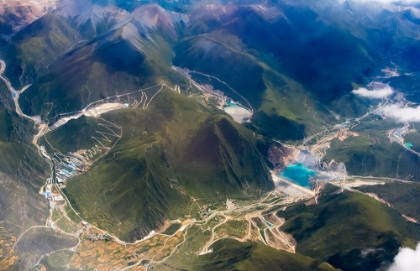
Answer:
[1,52,418,270]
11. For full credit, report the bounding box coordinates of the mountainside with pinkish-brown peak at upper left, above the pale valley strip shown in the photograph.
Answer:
[20,5,188,117]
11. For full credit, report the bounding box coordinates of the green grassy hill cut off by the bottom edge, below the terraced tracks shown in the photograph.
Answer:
[151,224,336,271]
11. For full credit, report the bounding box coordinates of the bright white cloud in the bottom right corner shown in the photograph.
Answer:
[388,243,420,271]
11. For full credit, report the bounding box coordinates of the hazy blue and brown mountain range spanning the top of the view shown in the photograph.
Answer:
[0,0,420,140]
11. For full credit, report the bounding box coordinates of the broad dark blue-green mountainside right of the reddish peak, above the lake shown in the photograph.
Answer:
[173,2,381,140]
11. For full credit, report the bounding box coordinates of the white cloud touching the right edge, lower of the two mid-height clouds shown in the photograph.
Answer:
[377,104,420,122]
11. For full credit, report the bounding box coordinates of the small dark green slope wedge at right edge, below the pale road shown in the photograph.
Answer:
[359,183,420,221]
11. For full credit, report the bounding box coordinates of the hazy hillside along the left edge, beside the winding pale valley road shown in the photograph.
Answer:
[0,79,49,234]
